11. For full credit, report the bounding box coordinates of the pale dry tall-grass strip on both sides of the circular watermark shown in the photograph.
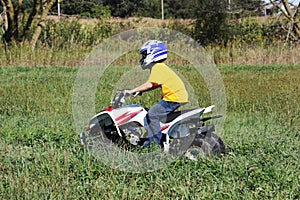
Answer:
[0,44,300,67]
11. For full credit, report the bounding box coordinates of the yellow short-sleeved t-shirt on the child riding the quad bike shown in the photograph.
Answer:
[148,63,188,103]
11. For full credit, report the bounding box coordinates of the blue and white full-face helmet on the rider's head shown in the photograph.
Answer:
[139,40,168,69]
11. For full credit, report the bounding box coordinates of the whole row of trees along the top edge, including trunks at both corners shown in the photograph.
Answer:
[0,0,300,47]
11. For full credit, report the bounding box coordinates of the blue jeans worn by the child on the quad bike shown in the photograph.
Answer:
[144,100,181,146]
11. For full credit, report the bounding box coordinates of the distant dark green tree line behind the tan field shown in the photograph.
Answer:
[54,0,263,19]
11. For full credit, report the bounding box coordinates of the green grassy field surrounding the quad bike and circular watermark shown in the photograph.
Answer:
[0,65,300,199]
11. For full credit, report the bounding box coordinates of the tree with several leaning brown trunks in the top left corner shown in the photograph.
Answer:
[0,0,57,48]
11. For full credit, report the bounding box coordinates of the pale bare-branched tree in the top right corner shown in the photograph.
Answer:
[270,0,300,40]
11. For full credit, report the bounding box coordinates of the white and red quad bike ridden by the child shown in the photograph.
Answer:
[79,90,225,161]
